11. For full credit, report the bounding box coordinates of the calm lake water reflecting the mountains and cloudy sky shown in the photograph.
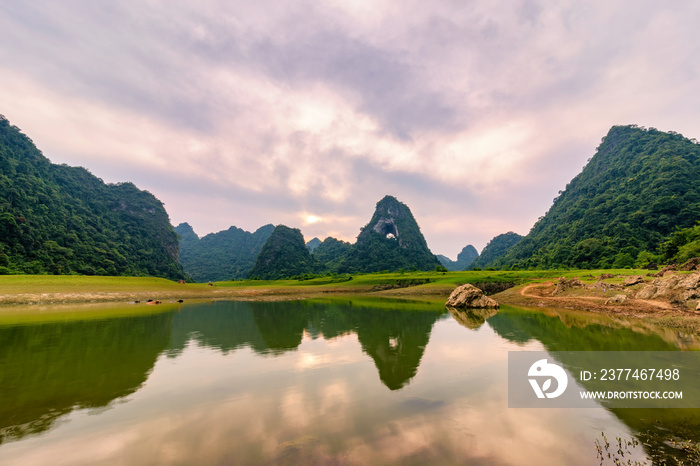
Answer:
[0,299,700,465]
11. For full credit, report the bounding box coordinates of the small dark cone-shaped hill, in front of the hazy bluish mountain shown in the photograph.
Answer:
[248,225,317,280]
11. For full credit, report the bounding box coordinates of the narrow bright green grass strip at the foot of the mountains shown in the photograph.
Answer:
[0,269,646,304]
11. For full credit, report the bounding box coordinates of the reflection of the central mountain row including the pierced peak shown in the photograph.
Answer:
[170,300,444,390]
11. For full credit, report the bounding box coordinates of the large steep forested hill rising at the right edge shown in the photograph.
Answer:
[493,125,700,268]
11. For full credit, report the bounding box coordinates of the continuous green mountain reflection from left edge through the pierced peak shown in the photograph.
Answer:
[0,301,444,444]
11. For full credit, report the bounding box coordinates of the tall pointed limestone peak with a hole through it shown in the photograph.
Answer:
[338,196,440,273]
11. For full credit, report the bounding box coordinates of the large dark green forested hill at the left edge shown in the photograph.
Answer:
[0,115,184,279]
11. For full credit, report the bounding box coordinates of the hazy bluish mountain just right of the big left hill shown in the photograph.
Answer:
[175,223,275,282]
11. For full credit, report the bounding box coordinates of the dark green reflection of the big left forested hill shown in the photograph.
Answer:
[0,313,173,444]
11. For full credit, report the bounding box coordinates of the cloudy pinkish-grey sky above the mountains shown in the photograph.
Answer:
[0,0,700,259]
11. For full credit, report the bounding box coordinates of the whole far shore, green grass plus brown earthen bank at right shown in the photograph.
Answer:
[0,270,700,335]
